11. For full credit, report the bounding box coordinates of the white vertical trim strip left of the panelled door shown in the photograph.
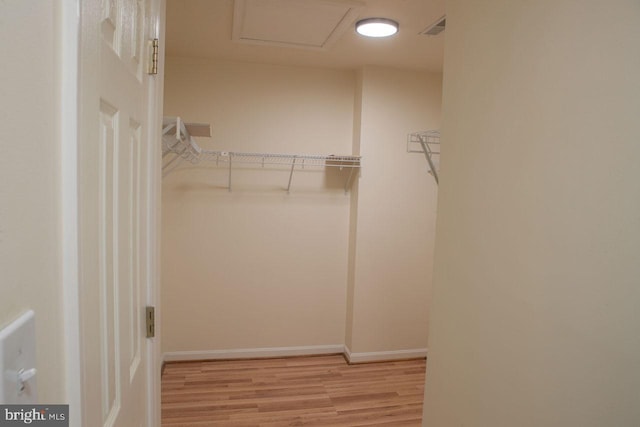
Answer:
[58,0,82,427]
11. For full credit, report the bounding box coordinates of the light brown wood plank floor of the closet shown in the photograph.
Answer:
[162,355,425,427]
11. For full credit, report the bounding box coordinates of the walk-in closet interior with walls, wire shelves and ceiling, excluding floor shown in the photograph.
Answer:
[161,0,444,422]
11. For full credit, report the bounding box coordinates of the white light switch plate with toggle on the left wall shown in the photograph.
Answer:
[0,310,37,404]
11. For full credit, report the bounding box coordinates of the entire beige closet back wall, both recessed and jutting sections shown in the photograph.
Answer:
[162,58,441,357]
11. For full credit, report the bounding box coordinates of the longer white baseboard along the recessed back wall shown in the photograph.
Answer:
[162,344,345,362]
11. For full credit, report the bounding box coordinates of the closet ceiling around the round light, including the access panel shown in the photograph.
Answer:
[166,0,445,72]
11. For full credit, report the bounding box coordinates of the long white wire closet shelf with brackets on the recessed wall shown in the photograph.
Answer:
[162,117,361,192]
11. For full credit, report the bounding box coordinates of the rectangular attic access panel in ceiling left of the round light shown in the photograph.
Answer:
[232,0,363,50]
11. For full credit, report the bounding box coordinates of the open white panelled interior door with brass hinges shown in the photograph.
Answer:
[78,0,156,427]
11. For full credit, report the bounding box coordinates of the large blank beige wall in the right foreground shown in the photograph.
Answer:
[424,0,640,427]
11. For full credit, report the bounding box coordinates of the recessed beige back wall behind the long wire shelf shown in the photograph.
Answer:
[162,58,355,352]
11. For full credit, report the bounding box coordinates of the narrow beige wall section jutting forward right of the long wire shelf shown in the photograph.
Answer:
[346,67,442,359]
